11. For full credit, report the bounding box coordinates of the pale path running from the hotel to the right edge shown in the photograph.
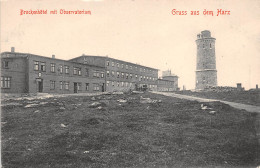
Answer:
[153,92,260,113]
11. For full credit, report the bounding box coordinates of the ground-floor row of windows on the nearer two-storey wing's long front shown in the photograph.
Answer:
[50,80,100,91]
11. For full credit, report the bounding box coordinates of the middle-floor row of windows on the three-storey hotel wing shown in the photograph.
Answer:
[107,71,156,81]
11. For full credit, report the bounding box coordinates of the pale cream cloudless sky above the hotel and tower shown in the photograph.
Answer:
[0,0,260,89]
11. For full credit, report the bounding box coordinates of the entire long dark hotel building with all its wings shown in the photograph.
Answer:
[1,48,178,94]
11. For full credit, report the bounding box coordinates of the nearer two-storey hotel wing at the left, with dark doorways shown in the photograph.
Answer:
[1,52,105,93]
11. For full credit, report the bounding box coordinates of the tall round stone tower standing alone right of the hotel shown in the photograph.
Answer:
[196,30,217,90]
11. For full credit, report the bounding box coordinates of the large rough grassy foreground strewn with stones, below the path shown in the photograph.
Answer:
[2,93,259,168]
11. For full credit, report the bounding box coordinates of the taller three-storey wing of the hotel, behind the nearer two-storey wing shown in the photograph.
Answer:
[70,55,158,91]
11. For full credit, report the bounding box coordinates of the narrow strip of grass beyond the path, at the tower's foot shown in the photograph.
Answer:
[178,90,260,106]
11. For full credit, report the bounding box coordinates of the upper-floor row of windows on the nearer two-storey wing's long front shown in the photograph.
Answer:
[34,61,104,78]
